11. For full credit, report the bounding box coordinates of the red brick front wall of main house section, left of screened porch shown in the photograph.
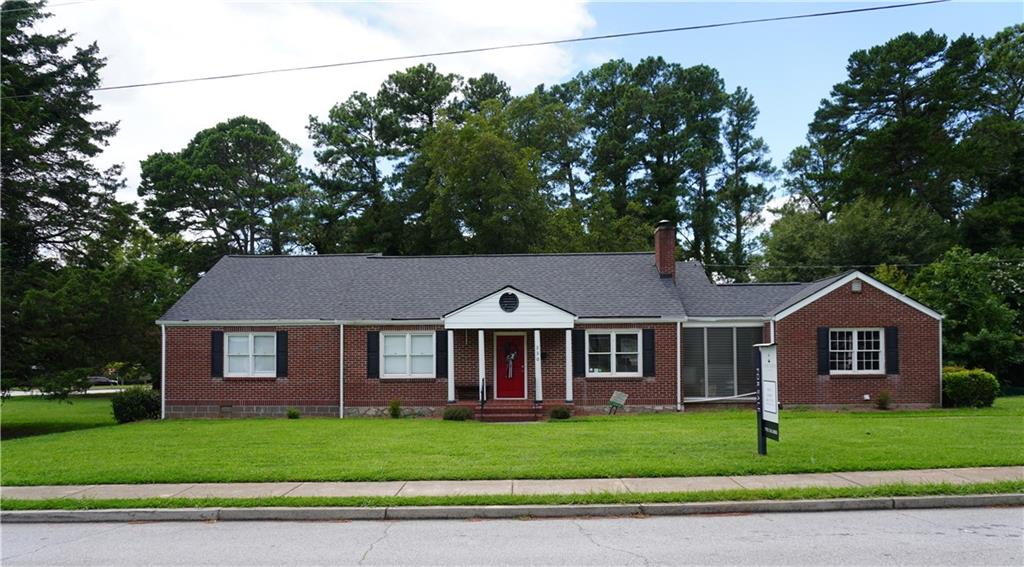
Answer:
[166,323,676,417]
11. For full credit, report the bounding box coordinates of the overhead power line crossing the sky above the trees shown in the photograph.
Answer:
[3,0,950,99]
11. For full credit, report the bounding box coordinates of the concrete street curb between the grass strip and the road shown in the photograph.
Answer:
[0,493,1024,524]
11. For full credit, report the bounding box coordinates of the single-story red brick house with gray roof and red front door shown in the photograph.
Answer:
[157,222,941,419]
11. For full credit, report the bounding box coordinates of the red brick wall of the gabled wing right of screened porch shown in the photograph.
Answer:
[778,281,940,406]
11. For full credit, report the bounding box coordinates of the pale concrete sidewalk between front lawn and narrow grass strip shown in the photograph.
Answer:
[0,467,1024,499]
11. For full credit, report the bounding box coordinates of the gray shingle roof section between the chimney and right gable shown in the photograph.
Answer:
[676,262,846,317]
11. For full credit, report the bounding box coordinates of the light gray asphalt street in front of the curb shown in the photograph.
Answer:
[0,508,1024,566]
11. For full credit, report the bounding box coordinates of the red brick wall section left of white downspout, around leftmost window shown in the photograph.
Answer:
[164,326,347,417]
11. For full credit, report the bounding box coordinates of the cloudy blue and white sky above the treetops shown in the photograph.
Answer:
[41,0,1024,201]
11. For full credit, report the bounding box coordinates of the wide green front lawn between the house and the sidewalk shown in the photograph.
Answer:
[0,398,1024,485]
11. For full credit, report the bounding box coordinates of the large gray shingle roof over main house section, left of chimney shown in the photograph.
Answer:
[162,253,684,320]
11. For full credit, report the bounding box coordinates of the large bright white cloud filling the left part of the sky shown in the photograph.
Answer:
[44,2,595,200]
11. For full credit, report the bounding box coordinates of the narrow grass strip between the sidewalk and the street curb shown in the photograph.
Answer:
[0,480,1024,511]
